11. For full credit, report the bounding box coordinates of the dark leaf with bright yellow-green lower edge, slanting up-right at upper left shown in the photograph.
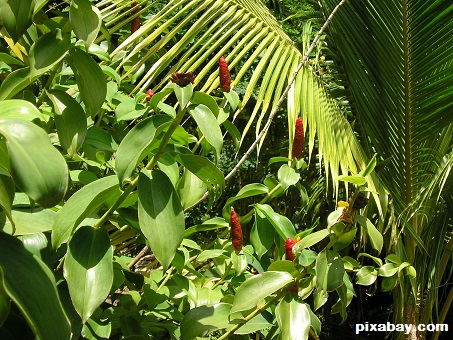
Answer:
[29,29,71,79]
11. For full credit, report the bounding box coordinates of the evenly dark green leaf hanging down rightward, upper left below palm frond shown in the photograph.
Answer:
[68,46,107,115]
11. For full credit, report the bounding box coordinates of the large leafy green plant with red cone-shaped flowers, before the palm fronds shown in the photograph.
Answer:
[0,0,415,339]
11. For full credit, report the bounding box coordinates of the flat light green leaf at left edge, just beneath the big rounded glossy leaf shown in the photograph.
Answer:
[3,208,56,235]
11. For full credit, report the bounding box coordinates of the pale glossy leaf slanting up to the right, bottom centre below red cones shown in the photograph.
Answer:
[230,271,294,314]
